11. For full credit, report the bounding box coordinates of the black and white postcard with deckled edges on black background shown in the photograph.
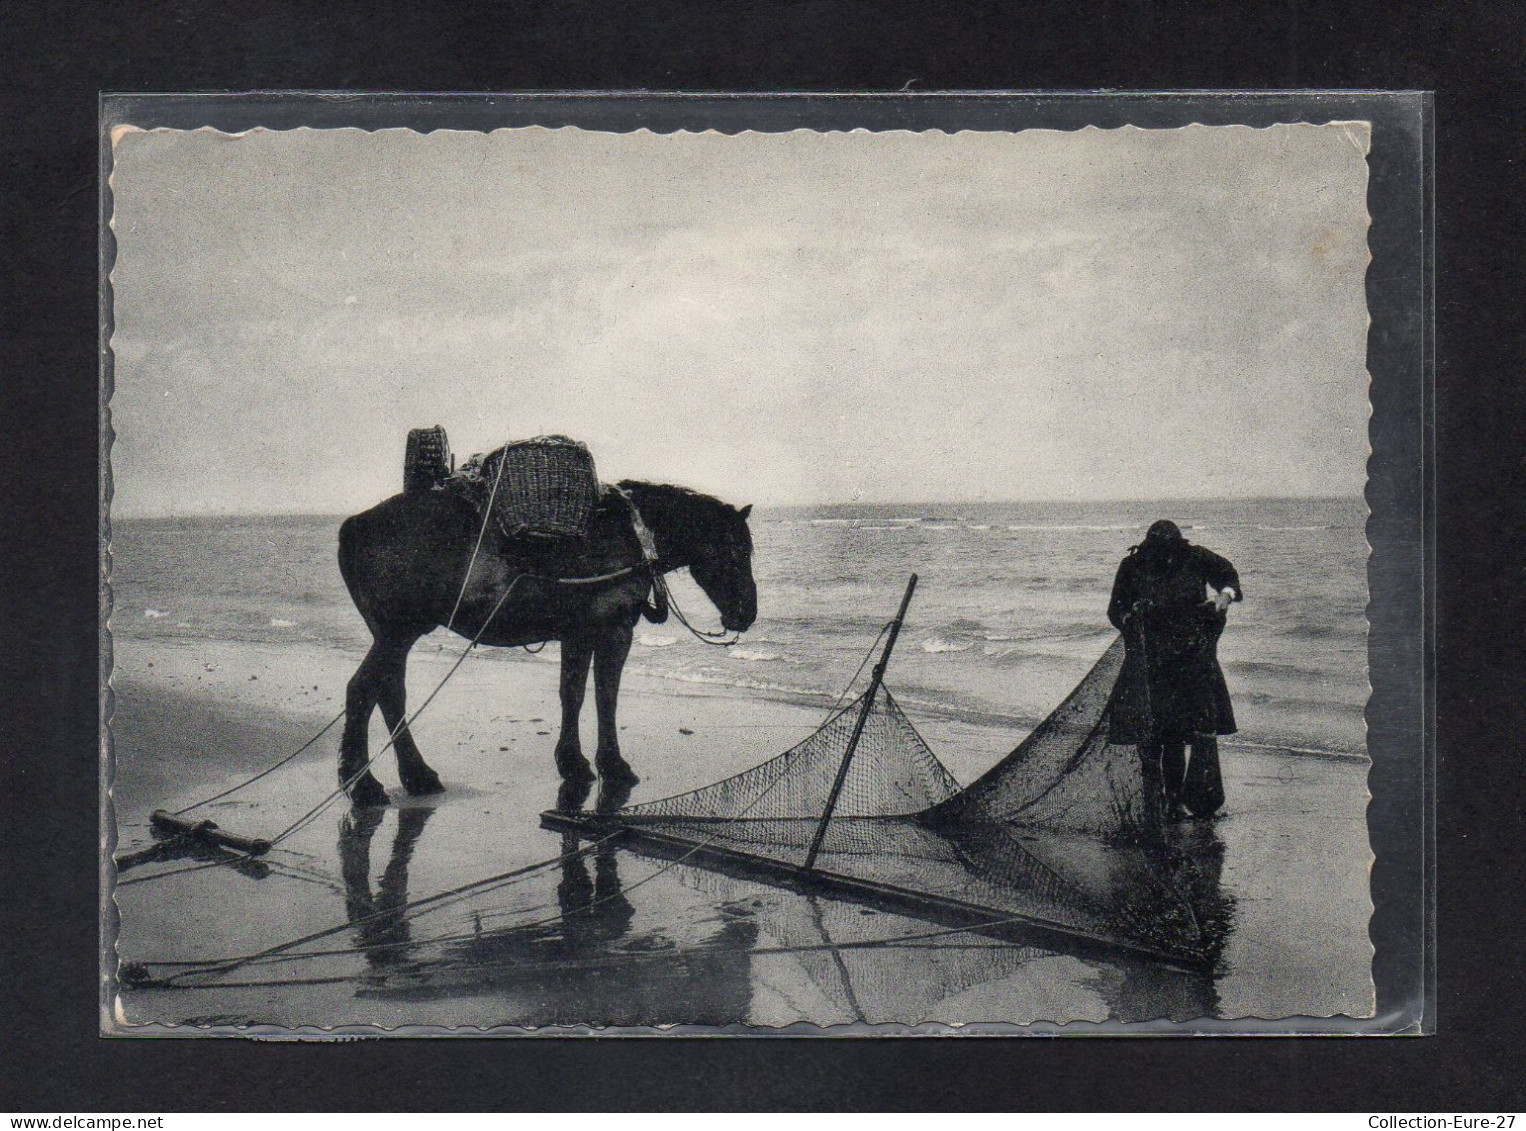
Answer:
[110,112,1385,1036]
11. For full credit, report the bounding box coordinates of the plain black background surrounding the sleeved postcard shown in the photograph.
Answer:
[0,0,1526,1111]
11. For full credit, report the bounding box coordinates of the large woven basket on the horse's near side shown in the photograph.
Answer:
[482,437,598,537]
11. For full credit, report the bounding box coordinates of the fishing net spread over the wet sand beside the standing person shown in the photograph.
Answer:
[573,640,1212,963]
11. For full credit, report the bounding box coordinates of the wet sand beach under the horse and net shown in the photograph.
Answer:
[113,638,1372,1032]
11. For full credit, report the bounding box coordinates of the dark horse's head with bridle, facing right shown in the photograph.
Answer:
[620,479,758,632]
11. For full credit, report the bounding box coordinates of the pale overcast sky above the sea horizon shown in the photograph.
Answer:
[111,124,1367,516]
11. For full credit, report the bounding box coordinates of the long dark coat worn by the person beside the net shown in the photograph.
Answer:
[1108,542,1244,743]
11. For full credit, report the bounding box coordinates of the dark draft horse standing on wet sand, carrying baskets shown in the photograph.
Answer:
[339,479,757,806]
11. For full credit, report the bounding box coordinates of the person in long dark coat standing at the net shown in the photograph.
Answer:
[1108,519,1244,820]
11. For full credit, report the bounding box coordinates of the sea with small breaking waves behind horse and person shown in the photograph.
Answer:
[110,498,1367,759]
